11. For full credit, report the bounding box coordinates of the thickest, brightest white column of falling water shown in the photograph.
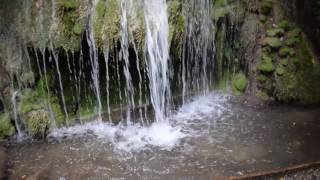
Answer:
[144,0,170,122]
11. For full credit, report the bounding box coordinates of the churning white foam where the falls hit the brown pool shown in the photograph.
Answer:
[49,94,228,152]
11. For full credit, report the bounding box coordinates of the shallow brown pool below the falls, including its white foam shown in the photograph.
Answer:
[4,93,320,179]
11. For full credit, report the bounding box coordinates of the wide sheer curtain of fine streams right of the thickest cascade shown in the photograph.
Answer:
[181,0,215,103]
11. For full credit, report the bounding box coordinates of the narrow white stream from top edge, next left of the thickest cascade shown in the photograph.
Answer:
[120,0,135,123]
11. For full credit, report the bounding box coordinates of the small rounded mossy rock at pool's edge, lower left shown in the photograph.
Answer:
[26,110,50,139]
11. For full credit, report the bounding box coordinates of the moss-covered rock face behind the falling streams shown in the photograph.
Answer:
[0,0,320,137]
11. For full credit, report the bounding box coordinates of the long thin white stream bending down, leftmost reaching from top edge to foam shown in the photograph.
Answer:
[87,0,102,121]
